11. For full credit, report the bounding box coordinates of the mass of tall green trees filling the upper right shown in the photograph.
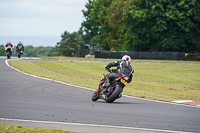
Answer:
[81,0,200,53]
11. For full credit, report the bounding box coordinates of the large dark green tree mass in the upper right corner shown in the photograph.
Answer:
[124,0,200,52]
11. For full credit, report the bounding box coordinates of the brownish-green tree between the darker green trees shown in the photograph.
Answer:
[99,0,129,51]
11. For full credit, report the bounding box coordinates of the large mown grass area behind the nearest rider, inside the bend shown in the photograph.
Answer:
[9,60,200,101]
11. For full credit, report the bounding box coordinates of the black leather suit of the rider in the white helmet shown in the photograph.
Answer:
[105,60,134,83]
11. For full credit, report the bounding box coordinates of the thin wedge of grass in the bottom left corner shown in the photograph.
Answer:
[0,124,72,133]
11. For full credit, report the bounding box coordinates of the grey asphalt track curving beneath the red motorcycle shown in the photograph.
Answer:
[0,58,200,133]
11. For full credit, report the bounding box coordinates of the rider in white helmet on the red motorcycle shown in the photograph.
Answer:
[105,55,134,87]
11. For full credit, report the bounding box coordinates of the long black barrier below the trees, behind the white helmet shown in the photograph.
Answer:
[95,51,185,60]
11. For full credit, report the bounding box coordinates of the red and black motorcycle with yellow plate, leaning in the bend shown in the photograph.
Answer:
[92,69,128,103]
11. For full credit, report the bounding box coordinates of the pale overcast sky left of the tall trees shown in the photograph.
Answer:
[0,0,87,36]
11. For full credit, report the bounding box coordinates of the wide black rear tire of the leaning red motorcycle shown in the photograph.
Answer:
[105,84,123,103]
